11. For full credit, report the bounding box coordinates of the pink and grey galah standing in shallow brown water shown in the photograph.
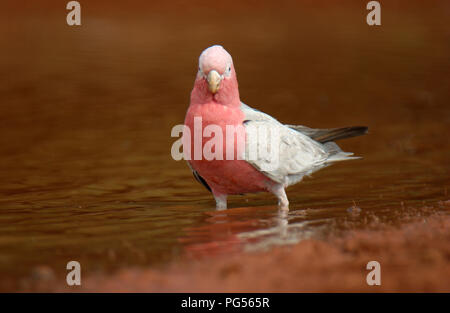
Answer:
[182,45,368,211]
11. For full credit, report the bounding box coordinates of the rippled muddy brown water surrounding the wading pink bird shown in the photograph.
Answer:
[0,1,450,282]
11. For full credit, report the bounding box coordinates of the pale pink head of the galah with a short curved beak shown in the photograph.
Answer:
[192,45,240,105]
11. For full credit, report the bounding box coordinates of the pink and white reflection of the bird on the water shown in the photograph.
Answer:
[180,206,310,257]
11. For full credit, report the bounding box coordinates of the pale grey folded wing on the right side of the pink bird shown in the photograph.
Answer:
[242,104,335,186]
